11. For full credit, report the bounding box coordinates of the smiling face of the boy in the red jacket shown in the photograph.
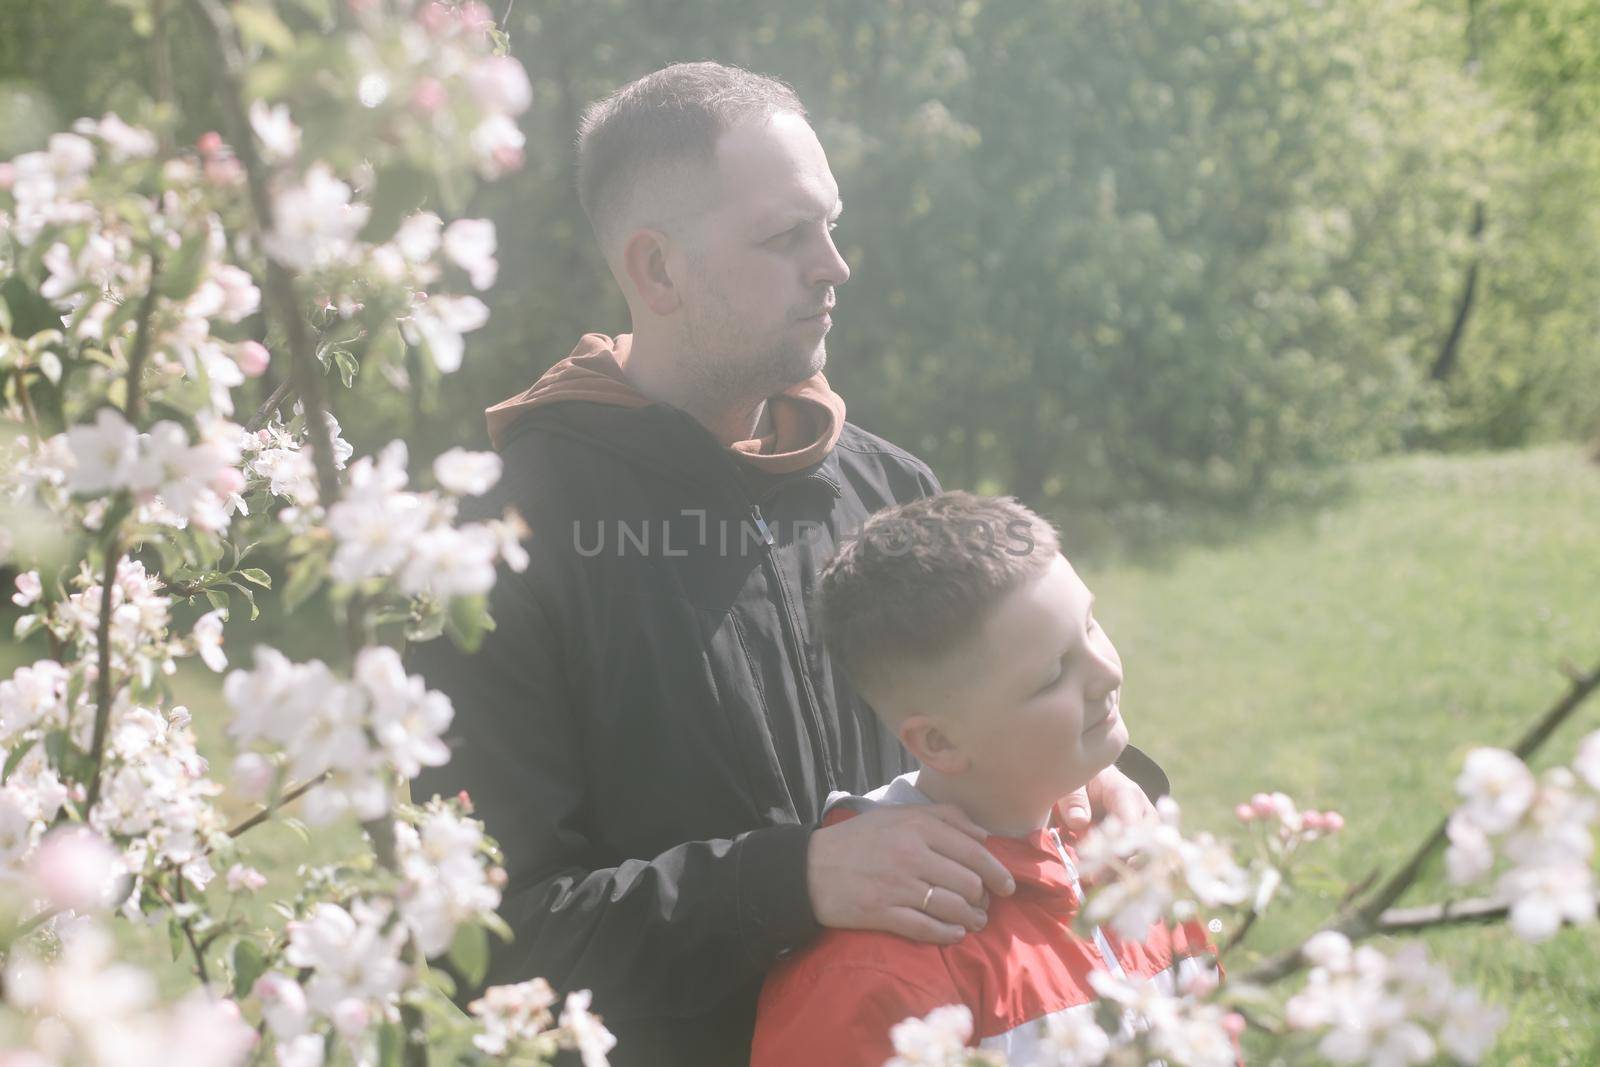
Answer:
[918,553,1128,817]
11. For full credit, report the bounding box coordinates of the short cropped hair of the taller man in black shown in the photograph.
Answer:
[578,61,806,254]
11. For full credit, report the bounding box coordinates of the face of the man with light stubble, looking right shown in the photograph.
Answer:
[680,112,850,398]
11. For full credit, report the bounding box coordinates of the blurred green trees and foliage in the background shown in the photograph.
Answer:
[0,0,1600,537]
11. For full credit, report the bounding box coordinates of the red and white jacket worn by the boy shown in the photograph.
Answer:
[750,776,1211,1067]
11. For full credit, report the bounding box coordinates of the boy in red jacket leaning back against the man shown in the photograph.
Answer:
[752,493,1208,1067]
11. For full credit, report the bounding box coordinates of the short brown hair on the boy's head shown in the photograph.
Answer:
[816,491,1061,710]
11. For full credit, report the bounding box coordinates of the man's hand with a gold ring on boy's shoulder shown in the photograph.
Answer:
[806,805,1016,944]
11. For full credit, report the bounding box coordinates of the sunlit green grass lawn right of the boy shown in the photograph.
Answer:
[1088,450,1600,1064]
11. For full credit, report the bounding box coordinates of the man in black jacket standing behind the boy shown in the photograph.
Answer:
[413,62,1163,1065]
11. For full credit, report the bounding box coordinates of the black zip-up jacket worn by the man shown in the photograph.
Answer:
[410,402,1171,1067]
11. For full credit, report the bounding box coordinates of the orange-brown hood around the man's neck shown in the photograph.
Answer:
[483,333,845,474]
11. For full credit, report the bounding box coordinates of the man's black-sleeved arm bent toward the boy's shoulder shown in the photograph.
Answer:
[408,571,816,1019]
